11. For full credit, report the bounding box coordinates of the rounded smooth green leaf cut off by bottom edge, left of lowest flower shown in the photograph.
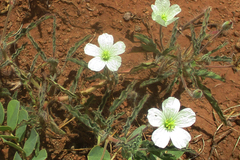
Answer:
[88,146,111,160]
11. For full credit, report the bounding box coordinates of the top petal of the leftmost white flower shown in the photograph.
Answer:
[98,33,113,50]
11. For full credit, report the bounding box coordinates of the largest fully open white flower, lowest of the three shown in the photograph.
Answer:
[147,97,196,149]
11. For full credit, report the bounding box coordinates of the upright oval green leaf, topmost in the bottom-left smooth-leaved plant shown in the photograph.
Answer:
[7,100,20,131]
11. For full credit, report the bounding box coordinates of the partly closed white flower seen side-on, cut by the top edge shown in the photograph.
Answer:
[151,0,181,27]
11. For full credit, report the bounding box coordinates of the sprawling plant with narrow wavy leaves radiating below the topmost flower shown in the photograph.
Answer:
[130,7,232,124]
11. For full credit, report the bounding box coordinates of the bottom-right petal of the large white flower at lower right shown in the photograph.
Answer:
[170,126,191,149]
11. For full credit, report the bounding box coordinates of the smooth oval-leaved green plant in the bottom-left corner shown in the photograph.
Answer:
[0,100,47,160]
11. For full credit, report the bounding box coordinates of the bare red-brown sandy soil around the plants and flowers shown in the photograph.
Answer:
[0,0,240,160]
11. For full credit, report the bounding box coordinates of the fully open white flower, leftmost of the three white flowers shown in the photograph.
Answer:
[84,33,126,71]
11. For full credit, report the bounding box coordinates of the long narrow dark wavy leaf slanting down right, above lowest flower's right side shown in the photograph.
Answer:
[197,78,227,125]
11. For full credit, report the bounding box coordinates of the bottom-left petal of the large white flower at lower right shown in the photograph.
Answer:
[152,127,170,148]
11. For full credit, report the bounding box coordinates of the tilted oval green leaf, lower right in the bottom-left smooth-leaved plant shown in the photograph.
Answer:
[23,128,38,156]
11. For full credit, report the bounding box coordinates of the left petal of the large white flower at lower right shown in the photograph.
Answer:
[147,108,165,127]
